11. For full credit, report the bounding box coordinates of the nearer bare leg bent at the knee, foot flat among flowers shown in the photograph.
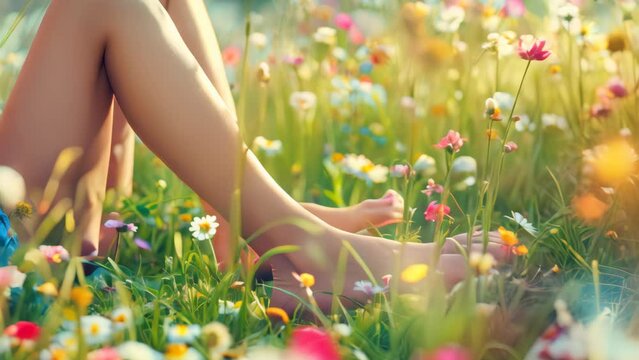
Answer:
[0,0,484,309]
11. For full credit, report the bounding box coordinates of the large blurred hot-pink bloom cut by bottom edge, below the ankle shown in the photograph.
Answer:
[289,326,340,360]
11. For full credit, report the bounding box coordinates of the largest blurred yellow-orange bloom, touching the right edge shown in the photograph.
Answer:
[583,140,639,186]
